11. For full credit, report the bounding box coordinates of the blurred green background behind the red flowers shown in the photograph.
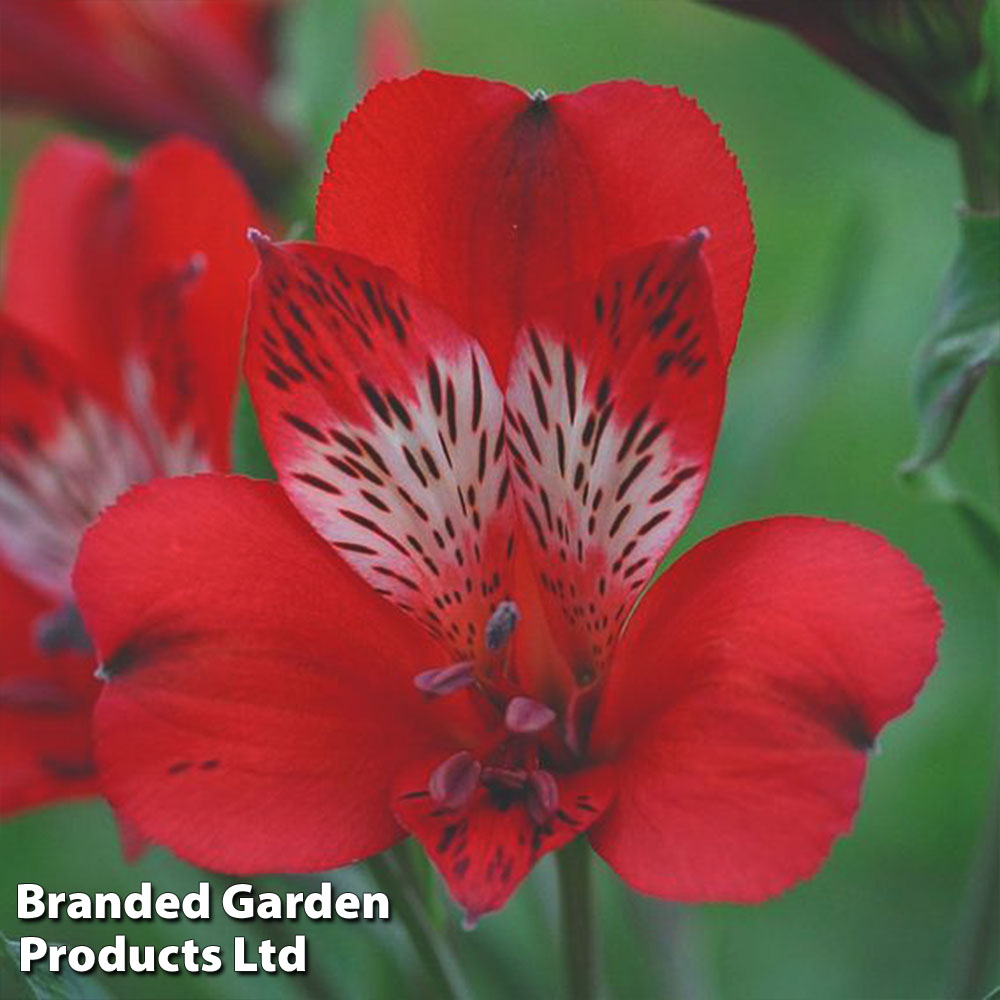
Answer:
[0,0,1000,1000]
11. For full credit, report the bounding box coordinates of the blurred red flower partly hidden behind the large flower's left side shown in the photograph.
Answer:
[0,139,254,814]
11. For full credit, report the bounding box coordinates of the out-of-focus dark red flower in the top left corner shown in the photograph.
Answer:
[0,0,298,193]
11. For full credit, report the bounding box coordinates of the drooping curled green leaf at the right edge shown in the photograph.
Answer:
[901,213,1000,474]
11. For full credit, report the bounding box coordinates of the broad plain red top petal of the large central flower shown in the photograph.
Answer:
[316,72,753,376]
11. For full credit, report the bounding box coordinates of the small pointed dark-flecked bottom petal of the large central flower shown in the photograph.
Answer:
[393,758,614,924]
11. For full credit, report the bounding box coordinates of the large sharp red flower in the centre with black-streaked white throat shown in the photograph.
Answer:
[75,77,940,919]
